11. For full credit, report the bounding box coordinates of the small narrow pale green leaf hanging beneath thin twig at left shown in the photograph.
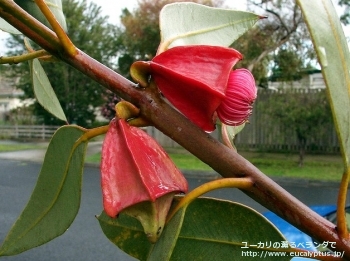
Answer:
[29,59,67,122]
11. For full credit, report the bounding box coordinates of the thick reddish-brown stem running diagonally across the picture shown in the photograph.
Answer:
[0,0,350,259]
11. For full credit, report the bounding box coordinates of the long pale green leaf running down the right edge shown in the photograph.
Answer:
[298,0,350,168]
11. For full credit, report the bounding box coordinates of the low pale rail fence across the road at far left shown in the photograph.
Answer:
[0,125,58,140]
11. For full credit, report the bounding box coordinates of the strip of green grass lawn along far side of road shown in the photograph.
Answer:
[86,150,343,181]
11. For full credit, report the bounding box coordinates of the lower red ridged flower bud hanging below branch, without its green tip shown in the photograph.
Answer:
[101,119,188,217]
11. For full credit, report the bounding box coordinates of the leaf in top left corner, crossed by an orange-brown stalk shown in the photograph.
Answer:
[14,0,67,31]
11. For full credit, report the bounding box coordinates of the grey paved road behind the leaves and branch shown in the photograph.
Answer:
[0,158,346,261]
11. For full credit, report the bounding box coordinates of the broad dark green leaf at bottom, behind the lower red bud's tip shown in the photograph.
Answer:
[99,198,290,261]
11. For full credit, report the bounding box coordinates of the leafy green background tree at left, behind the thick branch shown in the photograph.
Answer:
[4,0,118,127]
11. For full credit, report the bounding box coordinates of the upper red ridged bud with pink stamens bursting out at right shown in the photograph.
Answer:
[150,45,256,131]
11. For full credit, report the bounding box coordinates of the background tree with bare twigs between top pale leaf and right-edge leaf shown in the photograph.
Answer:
[233,0,315,87]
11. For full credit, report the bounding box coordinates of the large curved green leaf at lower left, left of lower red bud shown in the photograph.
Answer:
[0,126,87,256]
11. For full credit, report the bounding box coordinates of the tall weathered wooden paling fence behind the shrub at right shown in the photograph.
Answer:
[235,89,340,153]
